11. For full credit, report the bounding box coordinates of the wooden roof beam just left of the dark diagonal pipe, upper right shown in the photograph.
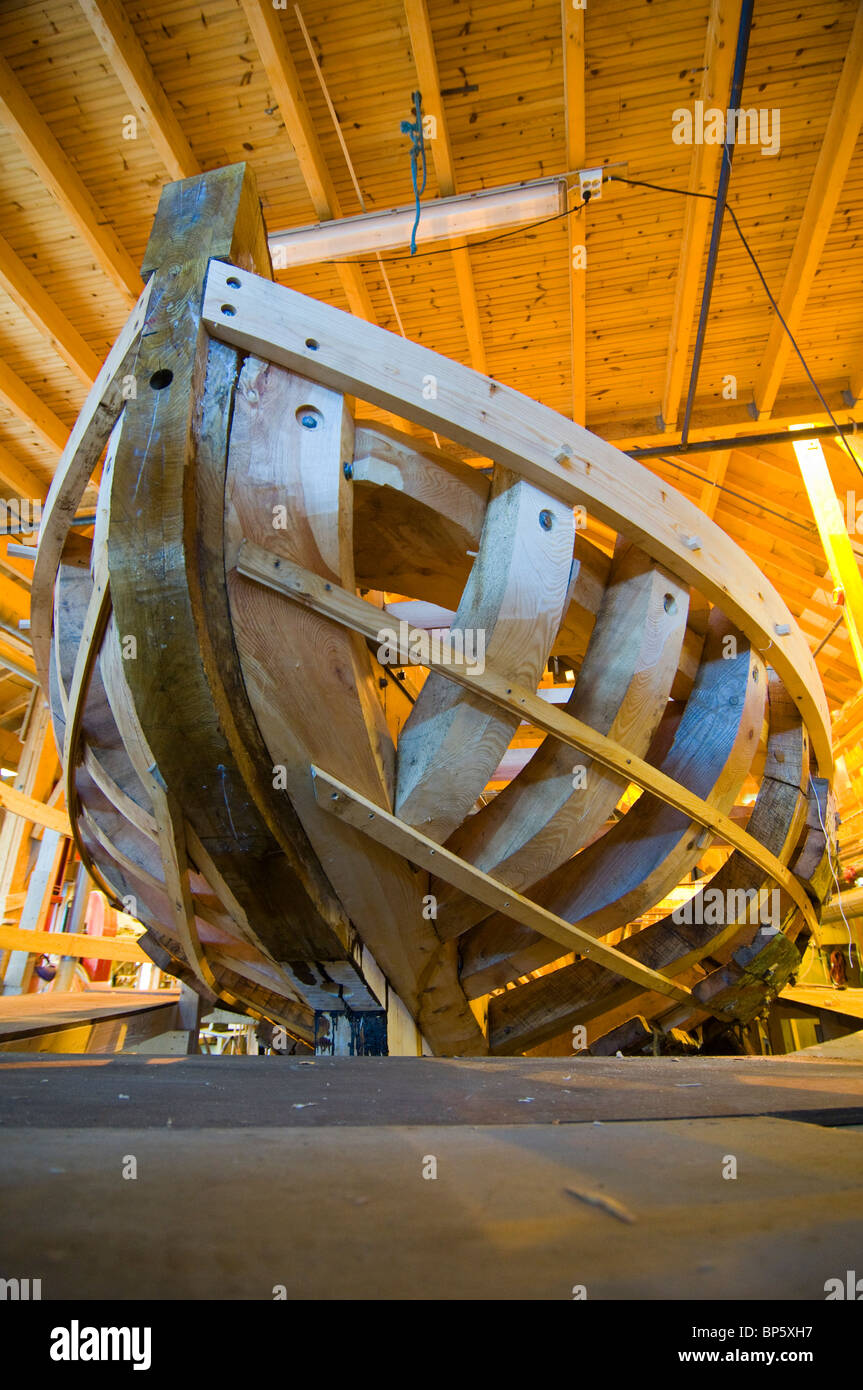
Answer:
[661,0,741,431]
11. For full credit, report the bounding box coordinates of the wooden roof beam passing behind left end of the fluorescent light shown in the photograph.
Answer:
[242,0,377,324]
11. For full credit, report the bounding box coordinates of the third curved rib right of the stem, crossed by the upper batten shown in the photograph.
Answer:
[432,542,689,937]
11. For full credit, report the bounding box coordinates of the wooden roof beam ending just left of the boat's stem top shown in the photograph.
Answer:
[0,57,140,303]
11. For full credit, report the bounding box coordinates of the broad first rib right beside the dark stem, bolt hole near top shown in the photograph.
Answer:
[227,359,485,1052]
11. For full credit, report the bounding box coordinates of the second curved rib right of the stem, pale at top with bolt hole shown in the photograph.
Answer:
[394,468,575,841]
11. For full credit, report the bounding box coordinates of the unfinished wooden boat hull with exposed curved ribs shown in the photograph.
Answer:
[32,165,835,1055]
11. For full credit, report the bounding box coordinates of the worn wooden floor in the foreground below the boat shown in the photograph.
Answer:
[0,1036,863,1301]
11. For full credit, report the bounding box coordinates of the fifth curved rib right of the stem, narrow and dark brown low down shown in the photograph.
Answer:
[489,676,809,1055]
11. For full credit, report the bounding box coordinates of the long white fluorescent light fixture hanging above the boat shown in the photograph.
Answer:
[270,178,567,270]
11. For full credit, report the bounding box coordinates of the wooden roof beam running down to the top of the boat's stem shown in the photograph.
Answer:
[78,0,200,179]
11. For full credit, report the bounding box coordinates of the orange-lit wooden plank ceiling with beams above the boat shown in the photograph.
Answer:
[0,0,863,766]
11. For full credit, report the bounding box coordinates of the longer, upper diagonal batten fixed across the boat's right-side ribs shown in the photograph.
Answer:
[238,541,817,931]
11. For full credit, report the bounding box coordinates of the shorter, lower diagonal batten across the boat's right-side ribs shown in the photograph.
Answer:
[311,767,689,1002]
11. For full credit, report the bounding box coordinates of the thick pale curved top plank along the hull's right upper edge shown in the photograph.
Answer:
[203,263,832,774]
